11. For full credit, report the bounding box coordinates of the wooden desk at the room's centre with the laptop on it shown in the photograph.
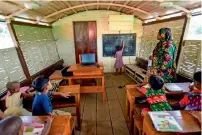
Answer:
[49,64,106,102]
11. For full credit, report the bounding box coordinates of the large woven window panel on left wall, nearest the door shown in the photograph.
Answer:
[14,24,59,75]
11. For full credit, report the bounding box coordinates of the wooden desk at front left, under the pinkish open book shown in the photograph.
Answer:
[21,115,75,135]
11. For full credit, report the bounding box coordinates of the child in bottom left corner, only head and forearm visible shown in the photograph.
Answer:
[0,116,53,135]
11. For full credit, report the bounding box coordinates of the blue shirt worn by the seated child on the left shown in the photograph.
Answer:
[32,92,53,116]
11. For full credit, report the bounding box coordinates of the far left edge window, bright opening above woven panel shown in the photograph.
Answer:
[0,22,26,93]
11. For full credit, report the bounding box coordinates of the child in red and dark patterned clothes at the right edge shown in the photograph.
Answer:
[179,71,201,111]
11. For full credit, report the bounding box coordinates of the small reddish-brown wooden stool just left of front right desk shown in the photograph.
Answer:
[133,116,143,135]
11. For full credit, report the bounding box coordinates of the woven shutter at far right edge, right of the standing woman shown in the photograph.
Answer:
[179,40,201,78]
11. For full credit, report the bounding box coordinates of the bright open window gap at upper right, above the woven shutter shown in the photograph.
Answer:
[186,15,202,40]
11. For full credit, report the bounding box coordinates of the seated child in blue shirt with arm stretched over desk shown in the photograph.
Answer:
[32,76,71,116]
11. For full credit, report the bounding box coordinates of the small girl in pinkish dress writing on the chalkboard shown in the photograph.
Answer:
[114,41,124,75]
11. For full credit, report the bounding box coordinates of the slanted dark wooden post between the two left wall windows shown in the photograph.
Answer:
[7,23,31,83]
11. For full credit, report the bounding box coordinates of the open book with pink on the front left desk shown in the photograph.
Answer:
[23,123,44,135]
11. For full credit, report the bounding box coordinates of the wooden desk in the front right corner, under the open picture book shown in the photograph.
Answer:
[143,111,201,135]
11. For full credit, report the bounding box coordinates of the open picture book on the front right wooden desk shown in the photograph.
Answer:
[149,112,183,132]
